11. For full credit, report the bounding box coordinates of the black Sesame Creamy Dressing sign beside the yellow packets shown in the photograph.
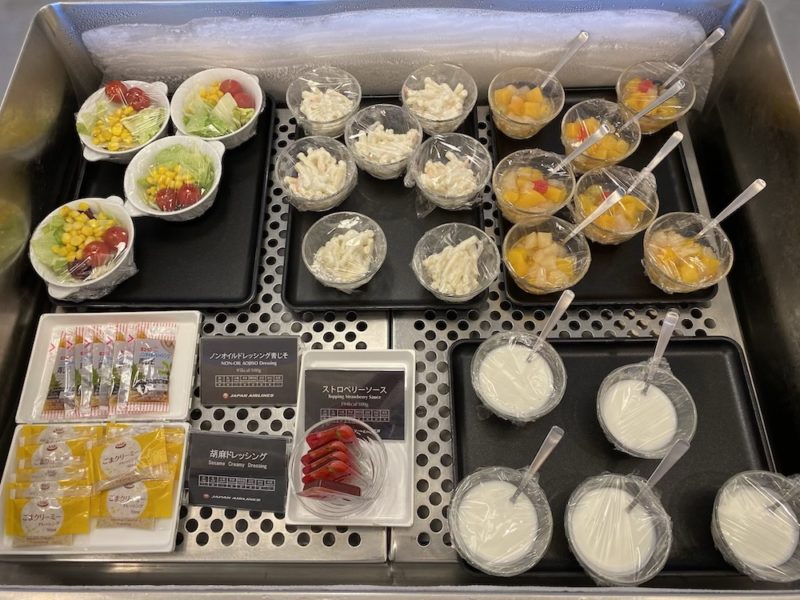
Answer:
[189,432,289,512]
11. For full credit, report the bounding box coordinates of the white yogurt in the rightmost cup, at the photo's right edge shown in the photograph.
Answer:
[717,485,800,568]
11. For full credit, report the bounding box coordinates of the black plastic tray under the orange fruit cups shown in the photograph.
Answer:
[492,89,717,306]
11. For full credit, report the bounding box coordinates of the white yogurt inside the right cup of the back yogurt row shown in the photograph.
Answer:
[600,379,678,452]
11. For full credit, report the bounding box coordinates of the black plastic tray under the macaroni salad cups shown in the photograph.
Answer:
[281,97,488,311]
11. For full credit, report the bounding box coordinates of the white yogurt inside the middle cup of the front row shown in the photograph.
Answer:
[567,487,656,578]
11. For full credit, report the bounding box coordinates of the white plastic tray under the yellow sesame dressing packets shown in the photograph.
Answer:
[0,422,189,555]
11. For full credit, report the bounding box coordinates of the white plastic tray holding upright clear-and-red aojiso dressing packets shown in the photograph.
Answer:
[17,310,201,423]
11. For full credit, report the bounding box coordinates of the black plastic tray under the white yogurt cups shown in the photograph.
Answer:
[450,337,773,587]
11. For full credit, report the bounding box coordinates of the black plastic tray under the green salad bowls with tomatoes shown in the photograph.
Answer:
[61,96,275,308]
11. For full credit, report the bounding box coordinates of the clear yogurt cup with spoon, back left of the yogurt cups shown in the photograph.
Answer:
[470,332,567,423]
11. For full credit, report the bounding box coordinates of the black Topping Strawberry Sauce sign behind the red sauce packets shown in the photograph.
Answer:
[304,369,406,440]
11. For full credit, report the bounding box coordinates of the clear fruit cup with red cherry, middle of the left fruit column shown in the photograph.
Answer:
[492,149,575,223]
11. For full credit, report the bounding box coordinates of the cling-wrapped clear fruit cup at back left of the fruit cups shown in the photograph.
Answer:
[489,67,564,140]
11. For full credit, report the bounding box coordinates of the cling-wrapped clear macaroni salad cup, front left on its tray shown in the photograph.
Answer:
[303,212,386,292]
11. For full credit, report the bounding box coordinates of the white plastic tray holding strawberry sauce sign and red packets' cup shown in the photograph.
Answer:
[286,350,415,527]
